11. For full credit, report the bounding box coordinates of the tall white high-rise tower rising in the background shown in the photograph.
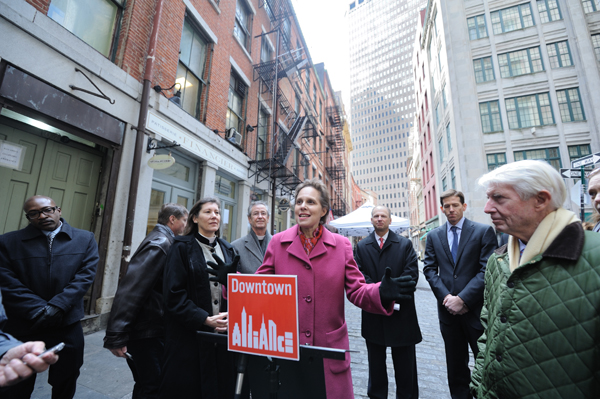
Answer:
[348,0,424,218]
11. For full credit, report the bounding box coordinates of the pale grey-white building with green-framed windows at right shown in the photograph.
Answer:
[415,0,600,223]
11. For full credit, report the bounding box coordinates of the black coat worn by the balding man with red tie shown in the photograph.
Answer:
[355,231,423,346]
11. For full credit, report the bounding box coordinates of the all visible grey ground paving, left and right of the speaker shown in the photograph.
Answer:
[32,265,450,399]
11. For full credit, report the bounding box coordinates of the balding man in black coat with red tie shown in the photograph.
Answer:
[355,206,422,399]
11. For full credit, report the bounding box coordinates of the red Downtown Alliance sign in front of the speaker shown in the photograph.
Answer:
[227,274,300,360]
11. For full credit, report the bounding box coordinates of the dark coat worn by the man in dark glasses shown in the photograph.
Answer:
[0,218,98,337]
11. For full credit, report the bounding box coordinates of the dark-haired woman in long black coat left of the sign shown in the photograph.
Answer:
[160,198,239,399]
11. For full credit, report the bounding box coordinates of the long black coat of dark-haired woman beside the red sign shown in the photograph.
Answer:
[160,235,235,399]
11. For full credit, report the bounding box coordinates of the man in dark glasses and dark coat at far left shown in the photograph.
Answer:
[0,195,98,399]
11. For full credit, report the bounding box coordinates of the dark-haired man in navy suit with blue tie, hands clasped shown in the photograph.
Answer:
[423,189,498,399]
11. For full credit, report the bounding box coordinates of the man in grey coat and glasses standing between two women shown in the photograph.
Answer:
[231,201,271,274]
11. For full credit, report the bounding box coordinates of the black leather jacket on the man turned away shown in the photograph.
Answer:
[104,225,174,349]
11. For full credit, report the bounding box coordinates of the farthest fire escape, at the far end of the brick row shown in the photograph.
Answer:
[325,104,350,216]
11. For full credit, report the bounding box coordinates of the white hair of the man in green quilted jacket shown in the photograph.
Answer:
[478,160,567,209]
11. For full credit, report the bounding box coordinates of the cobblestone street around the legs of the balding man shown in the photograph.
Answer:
[346,274,450,399]
